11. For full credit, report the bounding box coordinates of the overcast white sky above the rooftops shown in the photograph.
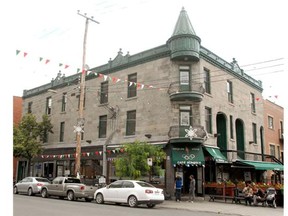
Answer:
[0,0,288,214]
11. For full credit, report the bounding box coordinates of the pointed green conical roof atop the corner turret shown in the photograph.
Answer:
[172,7,196,37]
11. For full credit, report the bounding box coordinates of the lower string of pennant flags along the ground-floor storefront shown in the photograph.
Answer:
[38,148,125,159]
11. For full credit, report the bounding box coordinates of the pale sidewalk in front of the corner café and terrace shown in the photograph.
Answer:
[158,197,284,216]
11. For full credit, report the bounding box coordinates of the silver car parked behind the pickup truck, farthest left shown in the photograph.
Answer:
[14,177,50,196]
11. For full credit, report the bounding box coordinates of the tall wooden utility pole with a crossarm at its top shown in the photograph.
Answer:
[75,10,100,177]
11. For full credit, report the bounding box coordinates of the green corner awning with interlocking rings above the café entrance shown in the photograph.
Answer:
[172,145,205,165]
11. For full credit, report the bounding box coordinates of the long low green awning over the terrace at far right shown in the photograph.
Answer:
[234,160,284,171]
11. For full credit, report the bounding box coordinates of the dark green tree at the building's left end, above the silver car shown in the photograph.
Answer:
[13,113,53,176]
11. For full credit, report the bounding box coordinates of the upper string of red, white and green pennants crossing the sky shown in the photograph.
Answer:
[16,50,278,98]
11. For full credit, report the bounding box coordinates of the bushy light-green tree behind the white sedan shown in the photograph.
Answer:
[115,142,166,179]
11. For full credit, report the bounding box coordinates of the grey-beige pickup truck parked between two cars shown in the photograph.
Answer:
[41,177,97,202]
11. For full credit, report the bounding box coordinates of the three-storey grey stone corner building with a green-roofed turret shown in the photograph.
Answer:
[19,8,280,195]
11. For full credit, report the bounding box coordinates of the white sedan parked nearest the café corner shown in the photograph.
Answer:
[94,180,164,208]
